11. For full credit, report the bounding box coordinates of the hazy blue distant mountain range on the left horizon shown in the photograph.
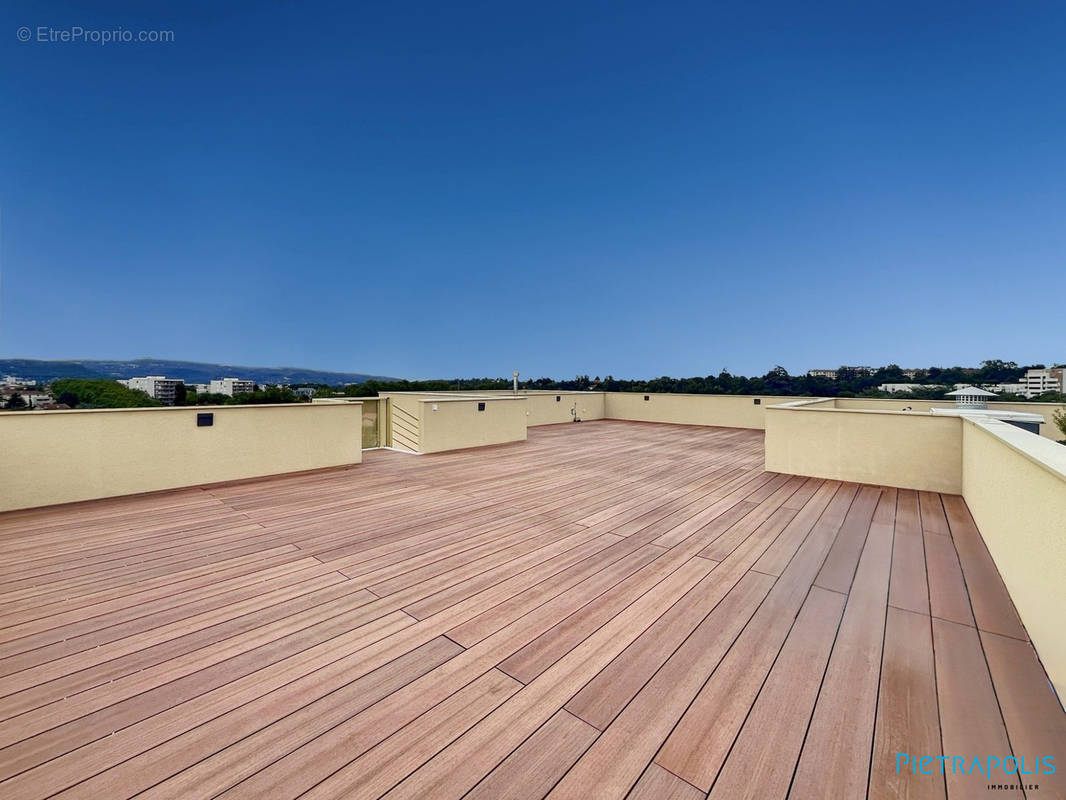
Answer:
[0,358,397,385]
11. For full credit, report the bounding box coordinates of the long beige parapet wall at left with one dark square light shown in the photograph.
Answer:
[0,402,362,511]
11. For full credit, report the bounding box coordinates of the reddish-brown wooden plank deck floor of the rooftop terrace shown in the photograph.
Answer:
[0,421,1066,800]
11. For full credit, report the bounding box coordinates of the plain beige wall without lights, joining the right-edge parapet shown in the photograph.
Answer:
[765,404,963,494]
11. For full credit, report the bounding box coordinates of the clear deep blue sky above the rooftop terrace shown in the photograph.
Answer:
[0,0,1066,378]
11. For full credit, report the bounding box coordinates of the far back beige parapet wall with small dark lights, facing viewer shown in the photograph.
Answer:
[605,391,814,430]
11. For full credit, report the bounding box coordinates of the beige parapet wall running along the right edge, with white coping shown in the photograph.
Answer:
[963,419,1066,699]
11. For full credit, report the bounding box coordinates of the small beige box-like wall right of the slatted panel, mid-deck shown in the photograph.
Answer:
[419,397,527,453]
